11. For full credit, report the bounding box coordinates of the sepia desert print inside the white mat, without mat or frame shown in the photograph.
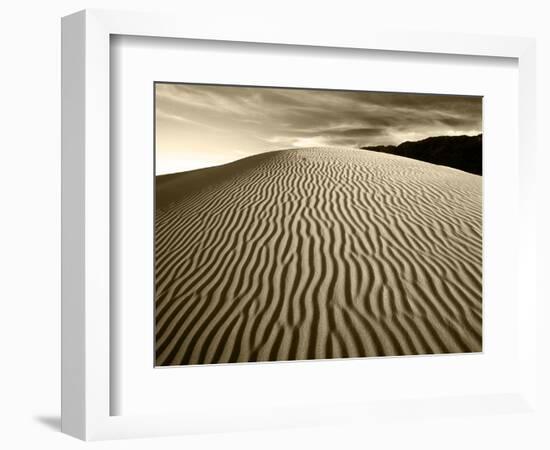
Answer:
[154,82,483,366]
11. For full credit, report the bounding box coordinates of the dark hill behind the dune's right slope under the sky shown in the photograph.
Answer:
[361,134,483,175]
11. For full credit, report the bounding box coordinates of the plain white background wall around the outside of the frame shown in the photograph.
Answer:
[0,0,550,449]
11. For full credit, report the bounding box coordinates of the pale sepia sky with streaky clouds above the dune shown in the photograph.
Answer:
[155,83,481,174]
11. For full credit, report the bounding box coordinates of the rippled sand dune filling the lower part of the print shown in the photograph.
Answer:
[155,148,482,365]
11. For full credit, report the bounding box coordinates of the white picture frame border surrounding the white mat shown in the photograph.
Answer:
[62,10,539,440]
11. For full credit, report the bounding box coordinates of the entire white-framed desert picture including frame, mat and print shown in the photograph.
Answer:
[62,10,536,440]
